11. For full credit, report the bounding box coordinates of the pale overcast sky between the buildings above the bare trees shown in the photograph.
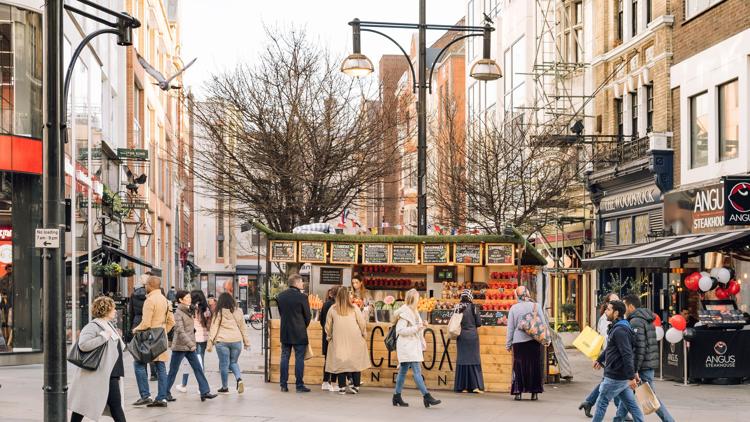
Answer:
[180,0,466,95]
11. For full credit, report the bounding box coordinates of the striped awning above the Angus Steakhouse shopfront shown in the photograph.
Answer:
[583,230,750,270]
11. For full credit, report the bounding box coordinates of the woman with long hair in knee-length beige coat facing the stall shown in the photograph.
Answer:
[325,289,370,394]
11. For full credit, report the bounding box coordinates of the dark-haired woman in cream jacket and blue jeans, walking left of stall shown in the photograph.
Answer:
[207,292,250,394]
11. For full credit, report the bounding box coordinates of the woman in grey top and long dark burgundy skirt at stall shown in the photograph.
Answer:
[505,286,549,400]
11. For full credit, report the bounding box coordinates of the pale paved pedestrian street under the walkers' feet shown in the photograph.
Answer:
[0,330,750,422]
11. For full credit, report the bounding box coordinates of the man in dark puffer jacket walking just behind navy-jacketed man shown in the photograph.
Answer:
[615,295,674,422]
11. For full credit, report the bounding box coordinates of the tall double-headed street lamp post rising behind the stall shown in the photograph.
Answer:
[341,0,502,236]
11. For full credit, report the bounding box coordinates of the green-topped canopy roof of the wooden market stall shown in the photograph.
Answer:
[252,221,547,265]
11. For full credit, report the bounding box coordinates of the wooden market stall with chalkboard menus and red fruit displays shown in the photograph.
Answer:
[256,224,546,392]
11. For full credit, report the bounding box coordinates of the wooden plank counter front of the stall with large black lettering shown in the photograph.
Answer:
[269,319,513,393]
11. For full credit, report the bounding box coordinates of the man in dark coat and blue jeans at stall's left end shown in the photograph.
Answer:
[276,274,312,393]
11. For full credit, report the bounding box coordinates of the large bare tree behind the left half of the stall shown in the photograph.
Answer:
[186,29,399,232]
